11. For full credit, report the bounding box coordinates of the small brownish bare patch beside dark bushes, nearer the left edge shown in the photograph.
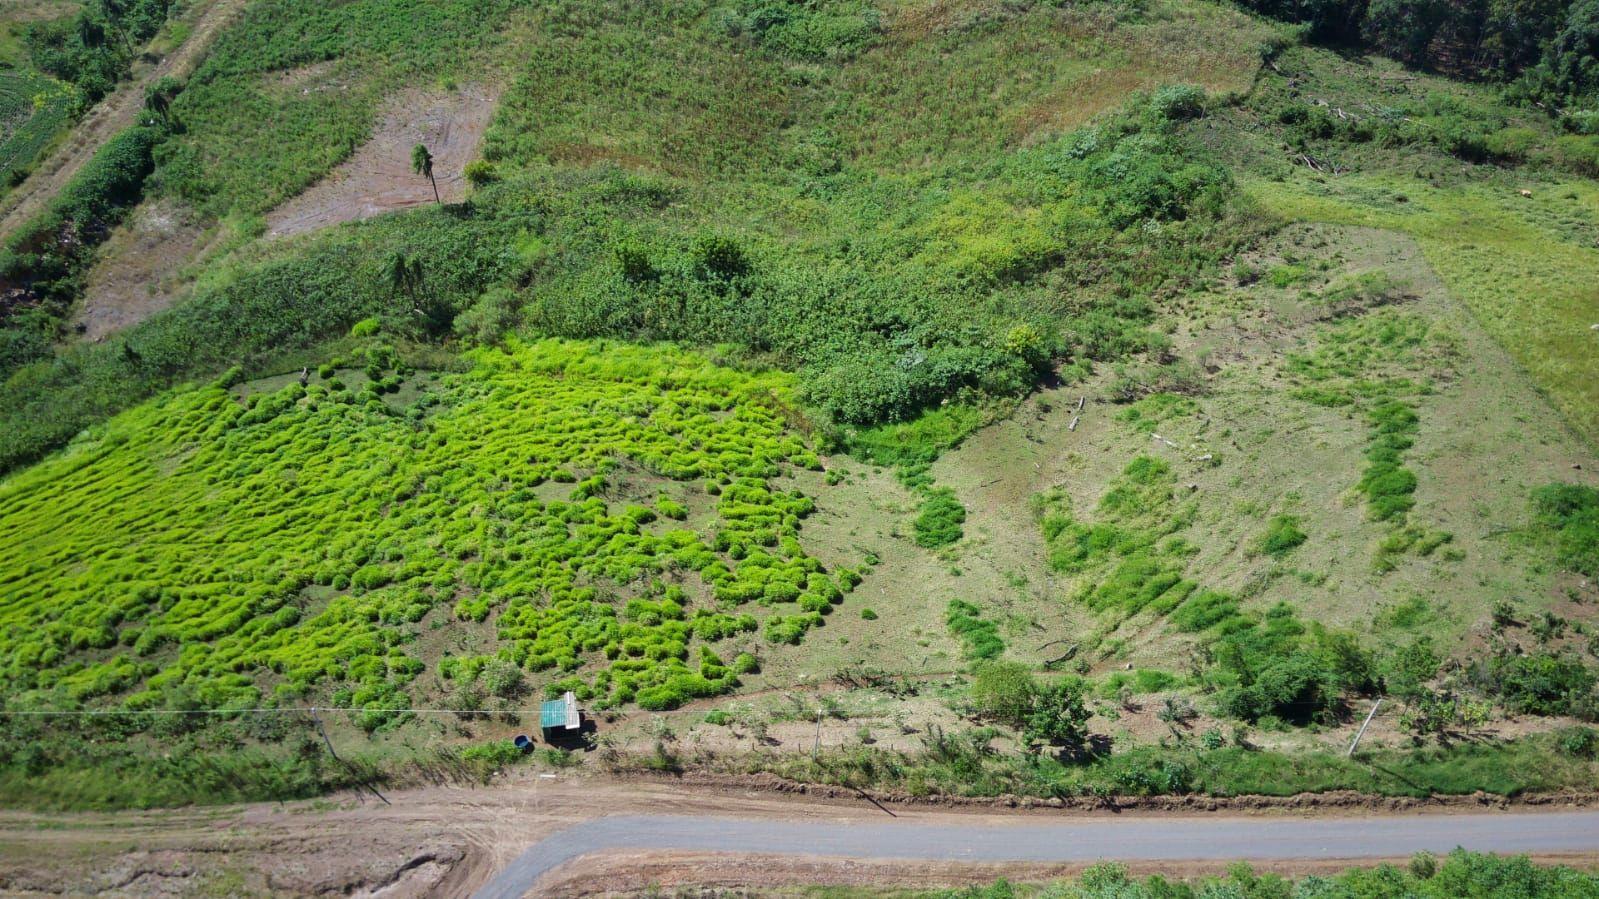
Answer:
[74,200,205,341]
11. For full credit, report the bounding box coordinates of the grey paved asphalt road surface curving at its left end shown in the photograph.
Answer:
[477,811,1599,899]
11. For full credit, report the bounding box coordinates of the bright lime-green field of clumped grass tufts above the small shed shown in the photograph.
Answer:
[0,342,854,716]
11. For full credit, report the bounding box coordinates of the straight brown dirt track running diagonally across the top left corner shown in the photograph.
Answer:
[0,0,248,240]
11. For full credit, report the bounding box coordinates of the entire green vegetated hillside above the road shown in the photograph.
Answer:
[0,0,1599,806]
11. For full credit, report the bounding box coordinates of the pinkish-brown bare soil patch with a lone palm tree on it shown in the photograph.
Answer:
[267,85,497,237]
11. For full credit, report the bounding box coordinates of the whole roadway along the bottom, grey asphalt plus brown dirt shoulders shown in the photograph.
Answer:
[0,773,1599,897]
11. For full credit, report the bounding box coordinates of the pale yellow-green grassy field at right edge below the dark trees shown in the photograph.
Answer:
[1228,50,1599,443]
